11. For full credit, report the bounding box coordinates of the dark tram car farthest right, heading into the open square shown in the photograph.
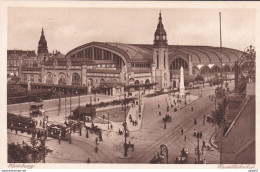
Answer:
[47,123,71,140]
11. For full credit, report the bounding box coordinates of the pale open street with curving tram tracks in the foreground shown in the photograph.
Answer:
[8,86,222,164]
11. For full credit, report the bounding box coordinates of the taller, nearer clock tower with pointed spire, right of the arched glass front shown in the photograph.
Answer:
[152,12,170,90]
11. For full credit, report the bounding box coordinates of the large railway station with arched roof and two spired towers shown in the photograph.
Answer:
[16,13,246,95]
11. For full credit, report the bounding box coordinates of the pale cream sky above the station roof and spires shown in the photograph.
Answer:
[7,7,256,54]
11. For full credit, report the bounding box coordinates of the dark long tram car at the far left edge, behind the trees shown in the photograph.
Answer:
[7,113,36,132]
